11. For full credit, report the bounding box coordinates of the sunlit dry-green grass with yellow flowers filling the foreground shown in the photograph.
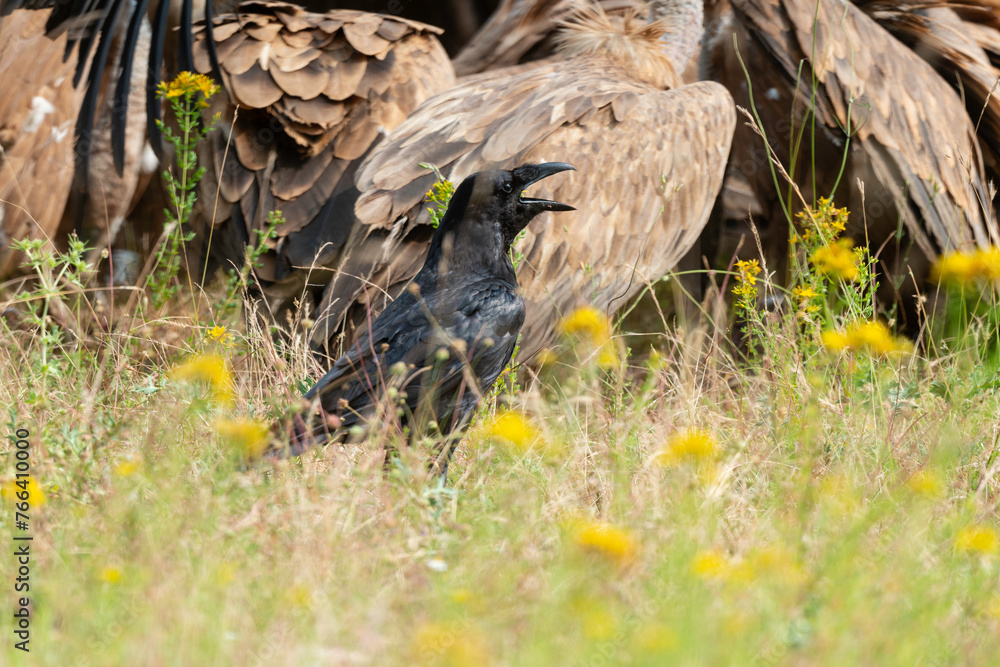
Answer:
[0,270,1000,665]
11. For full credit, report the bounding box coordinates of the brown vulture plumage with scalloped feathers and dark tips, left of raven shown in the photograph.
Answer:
[188,2,454,298]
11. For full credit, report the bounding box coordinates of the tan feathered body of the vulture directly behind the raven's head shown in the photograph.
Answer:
[292,1,735,359]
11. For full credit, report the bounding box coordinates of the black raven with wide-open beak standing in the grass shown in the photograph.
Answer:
[273,162,574,475]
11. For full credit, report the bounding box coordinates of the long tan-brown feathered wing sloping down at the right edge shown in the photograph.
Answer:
[729,0,998,258]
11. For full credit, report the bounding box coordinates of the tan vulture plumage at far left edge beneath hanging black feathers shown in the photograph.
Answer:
[0,9,157,276]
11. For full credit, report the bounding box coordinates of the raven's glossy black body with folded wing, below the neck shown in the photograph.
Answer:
[284,279,524,453]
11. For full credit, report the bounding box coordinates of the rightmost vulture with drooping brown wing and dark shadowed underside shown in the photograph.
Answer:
[703,0,1000,332]
